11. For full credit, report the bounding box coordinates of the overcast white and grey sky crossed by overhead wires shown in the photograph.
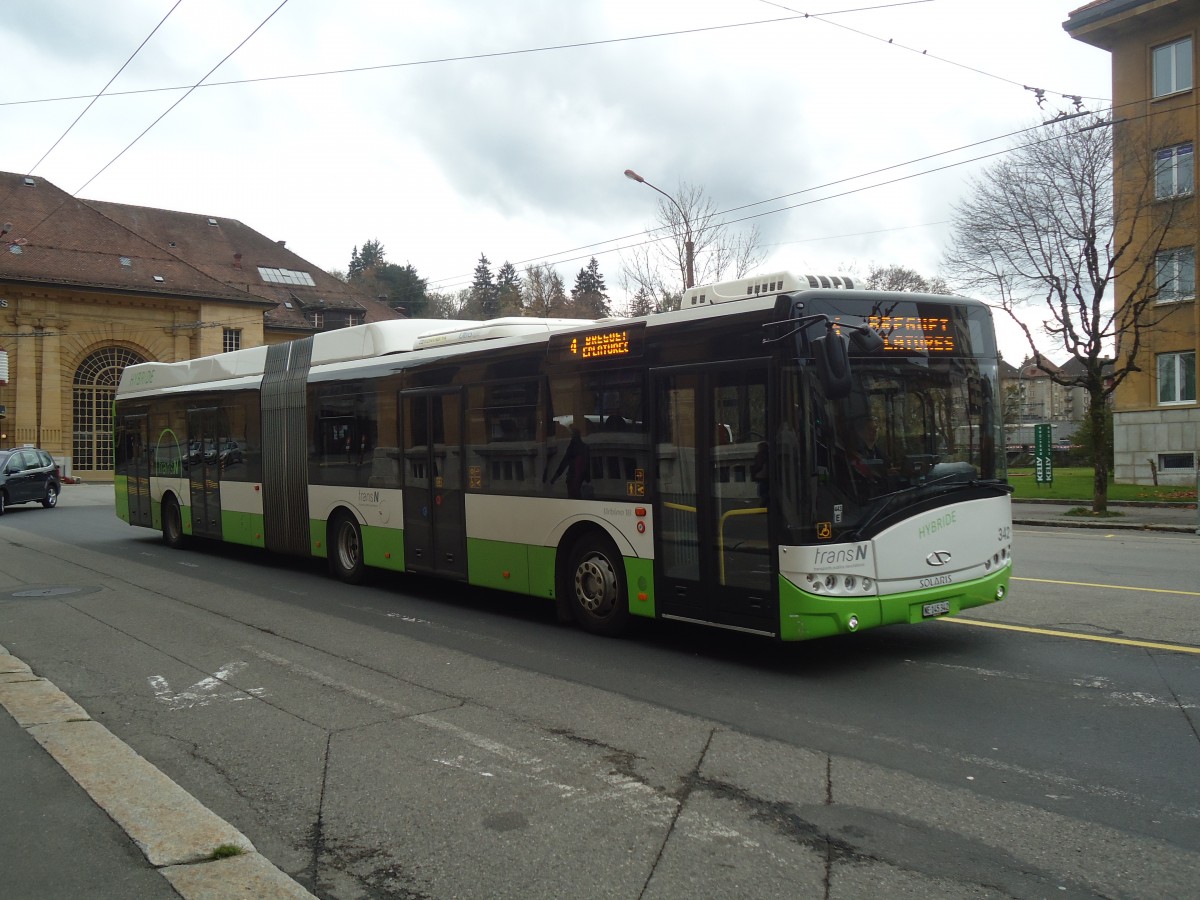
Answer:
[0,0,1111,358]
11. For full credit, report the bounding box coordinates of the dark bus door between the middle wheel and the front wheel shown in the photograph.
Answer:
[401,389,467,580]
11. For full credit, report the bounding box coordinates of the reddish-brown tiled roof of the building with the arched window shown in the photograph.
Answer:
[0,173,400,329]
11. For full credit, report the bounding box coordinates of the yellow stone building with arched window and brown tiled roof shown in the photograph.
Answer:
[0,173,400,481]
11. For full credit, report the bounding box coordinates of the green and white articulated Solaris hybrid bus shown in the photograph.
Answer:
[114,272,1013,641]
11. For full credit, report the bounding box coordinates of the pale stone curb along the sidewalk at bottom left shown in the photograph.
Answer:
[0,644,316,900]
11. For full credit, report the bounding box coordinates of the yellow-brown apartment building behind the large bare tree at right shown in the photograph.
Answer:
[1063,0,1200,484]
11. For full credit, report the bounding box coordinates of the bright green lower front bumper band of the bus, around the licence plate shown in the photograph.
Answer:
[779,568,1012,641]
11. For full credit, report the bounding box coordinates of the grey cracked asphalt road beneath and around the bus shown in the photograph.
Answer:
[0,488,1200,898]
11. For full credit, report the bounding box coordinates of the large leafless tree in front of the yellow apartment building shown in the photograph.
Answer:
[944,114,1194,514]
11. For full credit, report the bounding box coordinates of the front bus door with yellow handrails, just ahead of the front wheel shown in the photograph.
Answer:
[653,362,779,635]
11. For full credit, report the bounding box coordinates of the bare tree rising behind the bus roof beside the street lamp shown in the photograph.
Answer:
[622,184,767,311]
